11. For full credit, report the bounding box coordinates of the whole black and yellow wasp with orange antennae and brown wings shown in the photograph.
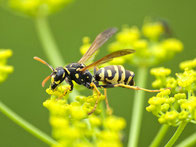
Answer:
[34,28,159,114]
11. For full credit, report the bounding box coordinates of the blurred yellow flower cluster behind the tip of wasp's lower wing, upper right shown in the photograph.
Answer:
[106,22,183,66]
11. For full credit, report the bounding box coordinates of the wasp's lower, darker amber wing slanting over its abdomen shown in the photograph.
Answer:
[81,49,135,71]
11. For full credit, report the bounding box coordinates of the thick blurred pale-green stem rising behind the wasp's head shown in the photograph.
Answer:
[35,17,64,67]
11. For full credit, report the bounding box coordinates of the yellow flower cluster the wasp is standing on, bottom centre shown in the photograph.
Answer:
[43,85,125,147]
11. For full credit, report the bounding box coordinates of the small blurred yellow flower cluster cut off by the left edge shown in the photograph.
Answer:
[0,49,14,83]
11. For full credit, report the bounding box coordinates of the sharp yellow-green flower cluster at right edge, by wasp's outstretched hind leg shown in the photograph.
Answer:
[146,59,196,126]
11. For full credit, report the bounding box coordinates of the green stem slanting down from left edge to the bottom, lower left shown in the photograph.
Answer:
[0,101,58,145]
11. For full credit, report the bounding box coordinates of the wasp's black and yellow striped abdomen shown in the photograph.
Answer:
[95,65,135,86]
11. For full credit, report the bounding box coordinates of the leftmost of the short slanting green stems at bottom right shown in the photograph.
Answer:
[150,125,169,147]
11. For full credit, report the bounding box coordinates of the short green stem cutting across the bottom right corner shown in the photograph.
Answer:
[176,133,196,147]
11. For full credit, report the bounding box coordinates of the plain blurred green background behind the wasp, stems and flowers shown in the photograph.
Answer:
[0,0,196,147]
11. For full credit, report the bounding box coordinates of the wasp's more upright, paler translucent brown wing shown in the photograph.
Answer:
[78,28,117,63]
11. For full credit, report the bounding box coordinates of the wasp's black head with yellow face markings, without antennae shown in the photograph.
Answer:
[51,67,65,89]
